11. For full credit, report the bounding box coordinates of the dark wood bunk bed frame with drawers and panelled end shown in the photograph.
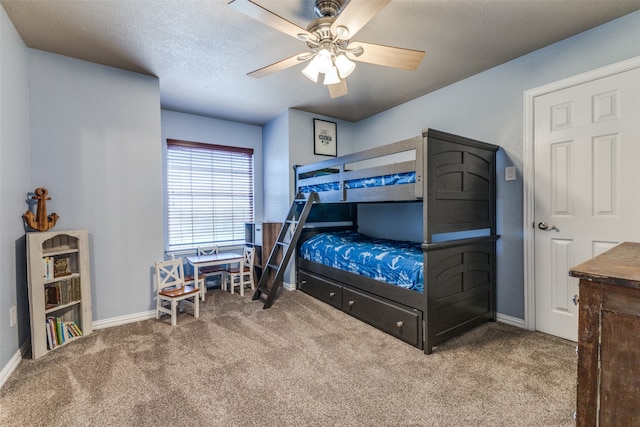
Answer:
[295,129,499,354]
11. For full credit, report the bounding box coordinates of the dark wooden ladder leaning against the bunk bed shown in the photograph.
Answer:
[253,192,318,308]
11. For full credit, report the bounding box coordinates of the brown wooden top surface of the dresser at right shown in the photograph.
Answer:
[569,242,640,289]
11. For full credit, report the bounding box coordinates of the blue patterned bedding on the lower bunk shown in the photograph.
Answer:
[300,231,424,292]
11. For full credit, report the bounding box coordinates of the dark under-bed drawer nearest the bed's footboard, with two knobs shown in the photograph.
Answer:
[342,287,422,348]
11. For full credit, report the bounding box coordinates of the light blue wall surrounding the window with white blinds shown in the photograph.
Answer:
[160,110,264,231]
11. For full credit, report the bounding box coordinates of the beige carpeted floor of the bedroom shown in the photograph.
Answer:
[0,290,577,427]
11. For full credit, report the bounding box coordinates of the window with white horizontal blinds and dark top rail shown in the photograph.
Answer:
[167,139,253,250]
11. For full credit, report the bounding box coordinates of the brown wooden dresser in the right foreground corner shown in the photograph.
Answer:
[569,243,640,427]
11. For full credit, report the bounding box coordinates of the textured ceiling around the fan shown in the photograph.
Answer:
[0,0,640,124]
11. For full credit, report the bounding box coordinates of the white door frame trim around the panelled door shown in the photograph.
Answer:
[522,56,640,331]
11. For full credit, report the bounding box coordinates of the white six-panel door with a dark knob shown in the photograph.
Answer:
[532,69,640,341]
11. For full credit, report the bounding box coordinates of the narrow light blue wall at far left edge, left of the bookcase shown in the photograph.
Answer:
[0,8,30,376]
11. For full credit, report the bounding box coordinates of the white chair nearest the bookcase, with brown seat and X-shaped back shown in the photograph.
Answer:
[156,258,200,326]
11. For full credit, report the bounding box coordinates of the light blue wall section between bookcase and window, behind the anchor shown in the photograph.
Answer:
[29,50,164,323]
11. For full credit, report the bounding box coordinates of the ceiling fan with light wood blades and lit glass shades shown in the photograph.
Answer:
[229,0,424,98]
